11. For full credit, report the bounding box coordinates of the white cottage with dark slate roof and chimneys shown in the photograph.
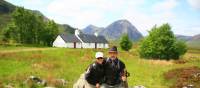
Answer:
[53,30,108,48]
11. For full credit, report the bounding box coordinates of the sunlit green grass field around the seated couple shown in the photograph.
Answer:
[0,47,200,88]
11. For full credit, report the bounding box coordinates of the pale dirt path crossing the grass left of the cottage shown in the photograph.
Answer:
[0,48,56,53]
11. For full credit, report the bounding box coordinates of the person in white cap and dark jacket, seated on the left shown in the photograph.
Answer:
[85,52,104,88]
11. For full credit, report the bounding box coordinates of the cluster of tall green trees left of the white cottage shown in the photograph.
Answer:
[3,7,59,46]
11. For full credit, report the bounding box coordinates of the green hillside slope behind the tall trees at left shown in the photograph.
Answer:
[0,0,75,34]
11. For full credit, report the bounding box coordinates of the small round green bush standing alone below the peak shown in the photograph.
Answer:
[120,34,133,51]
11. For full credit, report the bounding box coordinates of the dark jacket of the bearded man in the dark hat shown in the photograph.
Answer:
[104,58,125,85]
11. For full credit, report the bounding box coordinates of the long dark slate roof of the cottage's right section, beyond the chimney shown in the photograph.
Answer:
[78,34,108,43]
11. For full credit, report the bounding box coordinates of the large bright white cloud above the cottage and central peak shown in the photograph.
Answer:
[47,0,146,28]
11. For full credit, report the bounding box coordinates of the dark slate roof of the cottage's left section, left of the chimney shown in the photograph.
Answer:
[60,34,81,42]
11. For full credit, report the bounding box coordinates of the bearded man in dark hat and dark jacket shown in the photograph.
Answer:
[101,46,126,88]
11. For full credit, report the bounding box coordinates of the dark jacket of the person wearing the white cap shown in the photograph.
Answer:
[85,62,104,85]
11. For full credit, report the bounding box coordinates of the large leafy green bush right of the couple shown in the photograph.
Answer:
[139,24,187,60]
